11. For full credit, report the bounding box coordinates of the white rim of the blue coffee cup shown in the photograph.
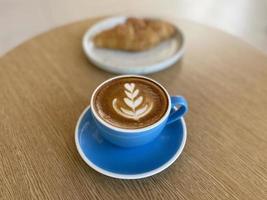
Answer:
[90,74,171,133]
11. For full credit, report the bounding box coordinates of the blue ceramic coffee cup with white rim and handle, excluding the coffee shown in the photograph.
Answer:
[91,75,188,147]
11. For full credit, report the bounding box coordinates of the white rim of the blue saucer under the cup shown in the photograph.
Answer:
[75,105,187,179]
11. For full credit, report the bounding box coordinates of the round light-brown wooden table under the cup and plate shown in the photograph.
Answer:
[0,19,267,200]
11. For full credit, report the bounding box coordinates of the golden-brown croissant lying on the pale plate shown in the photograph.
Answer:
[93,18,176,51]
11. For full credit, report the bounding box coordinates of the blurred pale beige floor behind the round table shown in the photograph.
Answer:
[0,0,267,56]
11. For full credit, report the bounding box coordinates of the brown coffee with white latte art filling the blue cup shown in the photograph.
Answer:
[92,76,169,129]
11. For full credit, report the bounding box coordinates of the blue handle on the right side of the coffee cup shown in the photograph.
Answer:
[167,96,188,124]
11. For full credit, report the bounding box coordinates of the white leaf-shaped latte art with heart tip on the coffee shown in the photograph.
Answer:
[112,83,153,120]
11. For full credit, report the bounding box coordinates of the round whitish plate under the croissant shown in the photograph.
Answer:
[83,17,184,74]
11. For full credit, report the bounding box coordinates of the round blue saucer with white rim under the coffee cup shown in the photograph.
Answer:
[75,106,186,179]
